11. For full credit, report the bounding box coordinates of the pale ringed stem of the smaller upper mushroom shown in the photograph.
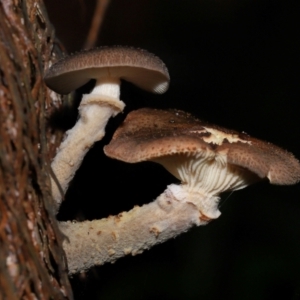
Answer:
[51,80,125,210]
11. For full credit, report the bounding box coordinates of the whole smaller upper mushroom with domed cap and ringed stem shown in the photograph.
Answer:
[44,46,170,206]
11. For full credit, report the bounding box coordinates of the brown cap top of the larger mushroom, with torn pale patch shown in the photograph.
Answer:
[104,108,300,185]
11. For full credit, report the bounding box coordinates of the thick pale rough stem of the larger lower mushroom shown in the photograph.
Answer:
[60,184,217,274]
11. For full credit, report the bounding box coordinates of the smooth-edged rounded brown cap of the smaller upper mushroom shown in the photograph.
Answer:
[44,46,170,94]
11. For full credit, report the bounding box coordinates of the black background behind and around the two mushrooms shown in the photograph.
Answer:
[46,0,300,300]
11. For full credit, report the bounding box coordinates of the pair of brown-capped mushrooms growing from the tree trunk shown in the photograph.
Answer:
[45,46,300,274]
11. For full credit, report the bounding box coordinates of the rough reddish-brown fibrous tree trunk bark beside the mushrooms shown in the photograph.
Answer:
[0,0,72,300]
